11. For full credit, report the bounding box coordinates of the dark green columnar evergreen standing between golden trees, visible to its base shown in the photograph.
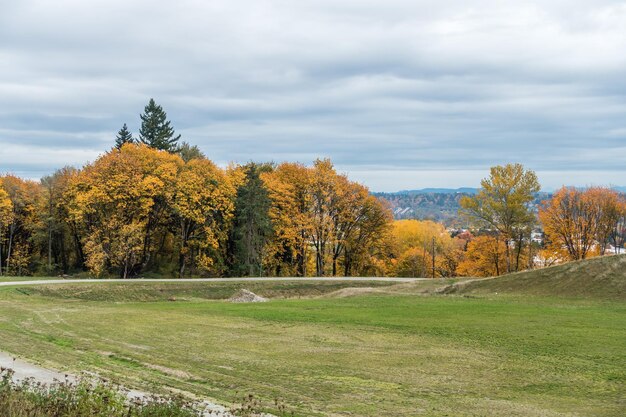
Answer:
[230,162,272,276]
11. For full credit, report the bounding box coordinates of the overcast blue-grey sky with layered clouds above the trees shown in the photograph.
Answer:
[0,0,626,191]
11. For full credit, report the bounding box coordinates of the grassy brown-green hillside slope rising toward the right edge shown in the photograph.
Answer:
[443,255,626,301]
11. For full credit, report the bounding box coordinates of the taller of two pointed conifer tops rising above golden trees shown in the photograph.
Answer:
[139,99,180,153]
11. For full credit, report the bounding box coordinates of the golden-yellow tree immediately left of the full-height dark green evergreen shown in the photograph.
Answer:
[172,158,236,277]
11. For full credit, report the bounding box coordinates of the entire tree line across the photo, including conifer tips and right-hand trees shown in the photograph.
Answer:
[0,99,626,277]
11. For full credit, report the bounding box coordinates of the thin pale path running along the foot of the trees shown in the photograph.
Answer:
[0,277,424,287]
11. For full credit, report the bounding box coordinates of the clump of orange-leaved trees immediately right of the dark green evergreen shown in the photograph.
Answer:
[262,159,391,276]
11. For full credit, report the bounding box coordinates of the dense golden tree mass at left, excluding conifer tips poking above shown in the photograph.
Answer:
[0,143,392,277]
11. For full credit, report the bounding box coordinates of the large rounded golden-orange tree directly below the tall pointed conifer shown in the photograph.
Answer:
[66,144,183,278]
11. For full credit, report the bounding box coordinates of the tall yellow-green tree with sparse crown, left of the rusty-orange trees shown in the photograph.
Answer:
[460,164,541,272]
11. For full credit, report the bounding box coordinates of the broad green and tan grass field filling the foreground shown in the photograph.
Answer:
[0,272,626,416]
